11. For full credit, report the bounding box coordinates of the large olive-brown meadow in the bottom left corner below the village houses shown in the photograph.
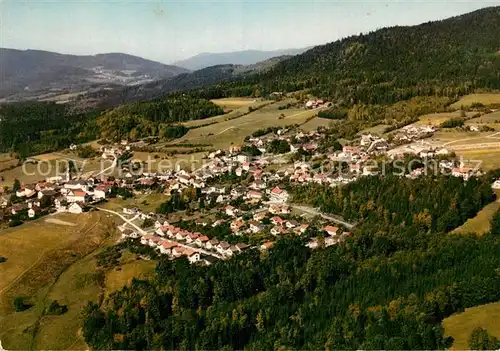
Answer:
[0,212,154,350]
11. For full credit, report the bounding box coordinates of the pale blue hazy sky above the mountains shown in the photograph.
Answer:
[0,0,500,63]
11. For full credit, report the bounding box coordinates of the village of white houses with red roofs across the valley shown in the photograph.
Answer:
[0,121,492,265]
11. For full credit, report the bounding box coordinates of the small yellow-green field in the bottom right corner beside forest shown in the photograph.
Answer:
[443,302,500,350]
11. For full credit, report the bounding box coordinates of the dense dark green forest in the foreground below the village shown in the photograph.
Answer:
[83,172,500,350]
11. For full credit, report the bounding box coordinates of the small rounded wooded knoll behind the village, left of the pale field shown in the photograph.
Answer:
[98,95,224,140]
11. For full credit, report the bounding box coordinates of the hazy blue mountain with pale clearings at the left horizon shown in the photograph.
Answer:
[0,48,188,98]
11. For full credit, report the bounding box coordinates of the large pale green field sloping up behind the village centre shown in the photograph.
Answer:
[169,103,324,148]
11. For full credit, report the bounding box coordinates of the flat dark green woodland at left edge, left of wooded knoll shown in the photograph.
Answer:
[0,102,99,158]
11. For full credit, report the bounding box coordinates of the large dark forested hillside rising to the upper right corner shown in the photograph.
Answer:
[194,7,500,105]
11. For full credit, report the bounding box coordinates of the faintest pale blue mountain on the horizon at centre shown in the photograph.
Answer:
[174,48,309,71]
